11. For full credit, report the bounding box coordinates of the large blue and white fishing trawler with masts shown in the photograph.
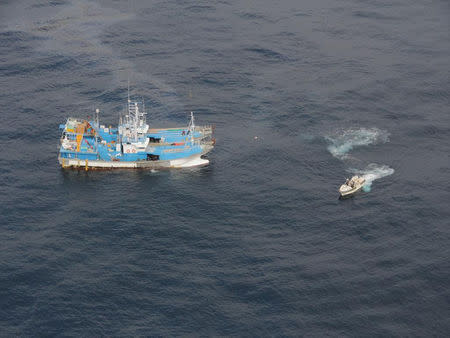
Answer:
[58,99,215,170]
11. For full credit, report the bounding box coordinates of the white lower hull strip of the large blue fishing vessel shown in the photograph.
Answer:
[58,154,209,170]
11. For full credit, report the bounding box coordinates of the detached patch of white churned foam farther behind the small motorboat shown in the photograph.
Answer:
[325,128,389,159]
